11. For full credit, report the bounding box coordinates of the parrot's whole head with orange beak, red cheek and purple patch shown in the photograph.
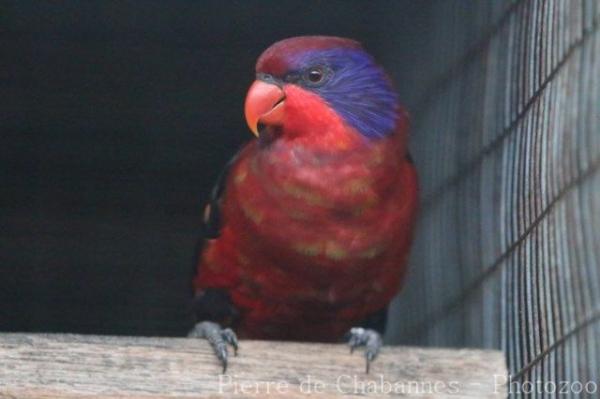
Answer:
[245,36,405,150]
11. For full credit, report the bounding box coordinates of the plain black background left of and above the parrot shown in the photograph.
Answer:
[0,1,430,335]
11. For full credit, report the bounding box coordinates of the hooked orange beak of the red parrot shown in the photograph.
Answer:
[244,80,285,136]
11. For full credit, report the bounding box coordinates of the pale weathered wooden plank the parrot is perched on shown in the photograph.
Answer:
[0,334,507,399]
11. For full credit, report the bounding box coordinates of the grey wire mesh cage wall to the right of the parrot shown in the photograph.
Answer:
[389,0,600,397]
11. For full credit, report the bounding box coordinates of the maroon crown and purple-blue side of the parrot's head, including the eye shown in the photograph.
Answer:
[257,36,399,139]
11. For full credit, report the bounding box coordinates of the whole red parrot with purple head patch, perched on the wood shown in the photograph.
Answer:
[190,36,418,371]
